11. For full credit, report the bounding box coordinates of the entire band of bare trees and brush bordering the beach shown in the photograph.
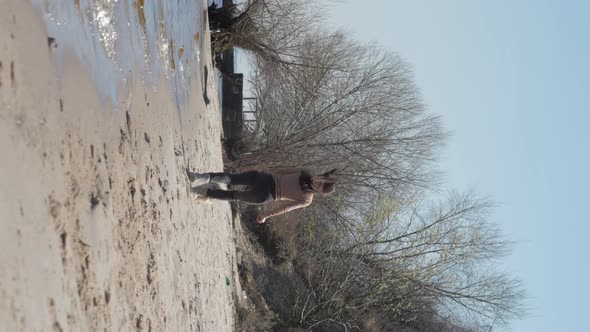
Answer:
[214,0,524,331]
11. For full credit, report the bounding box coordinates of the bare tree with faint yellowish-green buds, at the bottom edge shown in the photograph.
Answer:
[295,194,524,330]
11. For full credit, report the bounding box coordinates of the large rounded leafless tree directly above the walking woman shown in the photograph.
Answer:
[230,32,446,213]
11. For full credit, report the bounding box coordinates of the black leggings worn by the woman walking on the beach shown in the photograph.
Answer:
[207,171,275,204]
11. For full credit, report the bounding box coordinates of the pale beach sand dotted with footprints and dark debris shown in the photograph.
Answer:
[0,0,239,331]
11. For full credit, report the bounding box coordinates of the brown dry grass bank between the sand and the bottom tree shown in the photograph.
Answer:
[236,208,314,331]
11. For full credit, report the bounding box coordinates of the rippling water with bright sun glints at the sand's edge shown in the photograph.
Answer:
[32,0,206,104]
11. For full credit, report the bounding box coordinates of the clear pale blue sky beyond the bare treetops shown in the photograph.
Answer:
[328,0,590,332]
